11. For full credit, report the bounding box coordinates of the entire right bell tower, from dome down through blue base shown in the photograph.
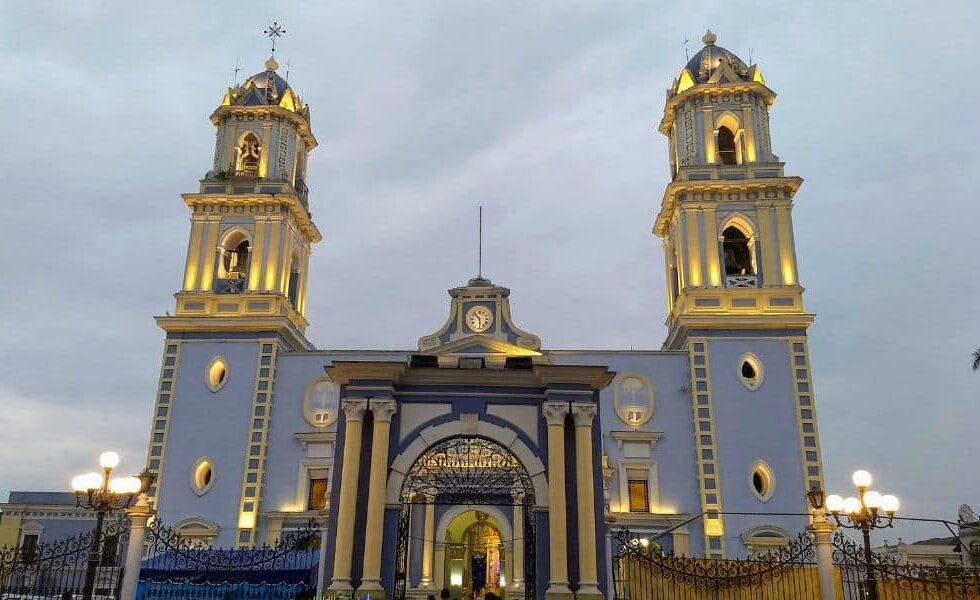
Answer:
[653,31,823,558]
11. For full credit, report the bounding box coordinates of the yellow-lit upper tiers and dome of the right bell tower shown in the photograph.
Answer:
[653,31,813,349]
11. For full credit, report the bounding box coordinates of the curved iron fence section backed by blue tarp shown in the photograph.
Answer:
[136,521,320,600]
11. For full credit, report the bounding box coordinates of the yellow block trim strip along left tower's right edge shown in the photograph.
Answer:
[235,338,279,548]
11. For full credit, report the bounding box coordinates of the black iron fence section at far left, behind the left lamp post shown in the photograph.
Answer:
[0,521,129,599]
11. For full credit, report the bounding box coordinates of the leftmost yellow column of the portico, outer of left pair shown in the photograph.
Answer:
[329,400,367,593]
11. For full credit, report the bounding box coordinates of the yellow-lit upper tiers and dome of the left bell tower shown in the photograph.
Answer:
[157,58,321,348]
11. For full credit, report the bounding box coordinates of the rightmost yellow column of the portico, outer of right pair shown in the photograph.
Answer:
[572,402,602,600]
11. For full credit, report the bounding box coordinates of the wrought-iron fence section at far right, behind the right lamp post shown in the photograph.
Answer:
[834,531,980,600]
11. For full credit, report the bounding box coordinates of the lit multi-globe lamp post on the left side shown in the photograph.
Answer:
[71,452,154,600]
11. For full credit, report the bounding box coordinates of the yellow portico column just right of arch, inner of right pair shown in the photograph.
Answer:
[541,402,572,600]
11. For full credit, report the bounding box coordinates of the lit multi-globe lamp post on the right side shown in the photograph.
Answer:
[824,470,898,600]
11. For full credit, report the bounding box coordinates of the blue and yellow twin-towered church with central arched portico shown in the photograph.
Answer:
[147,32,822,598]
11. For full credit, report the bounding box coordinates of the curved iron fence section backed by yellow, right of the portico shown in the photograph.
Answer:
[613,530,820,600]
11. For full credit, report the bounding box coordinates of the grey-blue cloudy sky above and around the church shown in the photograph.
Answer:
[0,0,980,538]
